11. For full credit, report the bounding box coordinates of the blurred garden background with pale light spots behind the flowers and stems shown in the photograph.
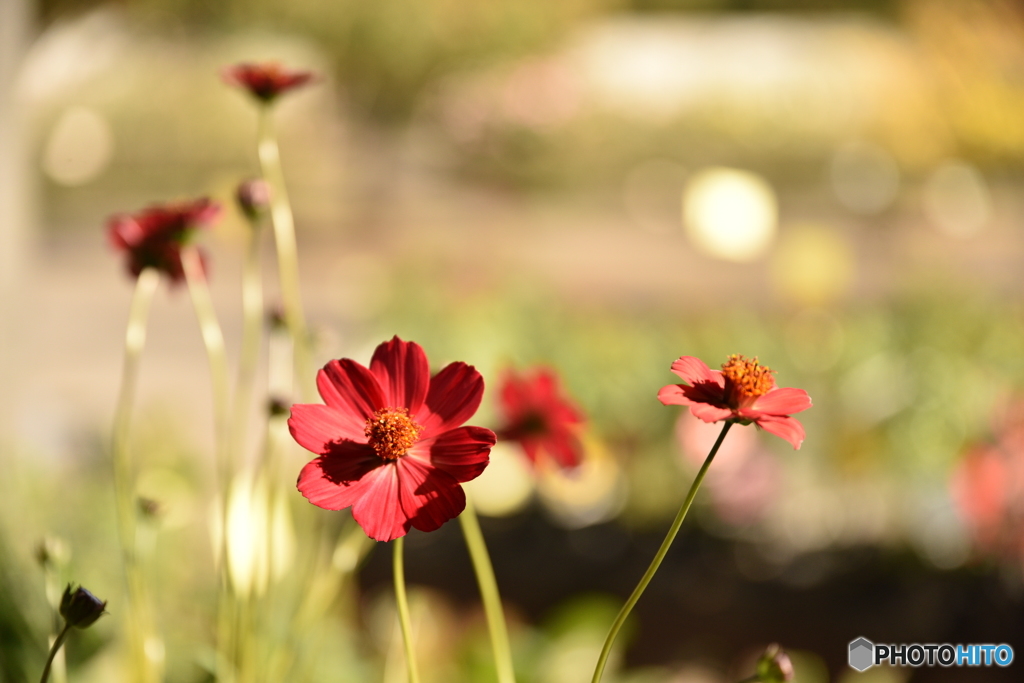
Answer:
[0,0,1024,683]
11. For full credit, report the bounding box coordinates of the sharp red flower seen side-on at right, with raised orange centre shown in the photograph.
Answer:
[657,354,811,449]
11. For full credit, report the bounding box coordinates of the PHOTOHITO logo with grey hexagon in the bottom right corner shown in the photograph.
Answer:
[849,637,1014,671]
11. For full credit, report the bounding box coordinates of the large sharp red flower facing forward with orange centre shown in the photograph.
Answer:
[288,337,496,541]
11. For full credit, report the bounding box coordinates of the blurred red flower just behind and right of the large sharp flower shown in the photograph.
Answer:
[499,368,583,468]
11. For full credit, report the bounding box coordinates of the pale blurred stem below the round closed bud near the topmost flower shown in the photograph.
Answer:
[231,220,263,466]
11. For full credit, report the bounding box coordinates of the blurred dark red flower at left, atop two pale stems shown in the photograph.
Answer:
[106,198,220,284]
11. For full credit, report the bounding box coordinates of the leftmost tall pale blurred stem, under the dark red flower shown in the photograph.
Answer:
[112,268,160,682]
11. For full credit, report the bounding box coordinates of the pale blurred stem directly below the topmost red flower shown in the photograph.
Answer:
[258,105,315,400]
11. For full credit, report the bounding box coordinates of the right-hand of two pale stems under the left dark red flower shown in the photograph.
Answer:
[181,247,238,681]
